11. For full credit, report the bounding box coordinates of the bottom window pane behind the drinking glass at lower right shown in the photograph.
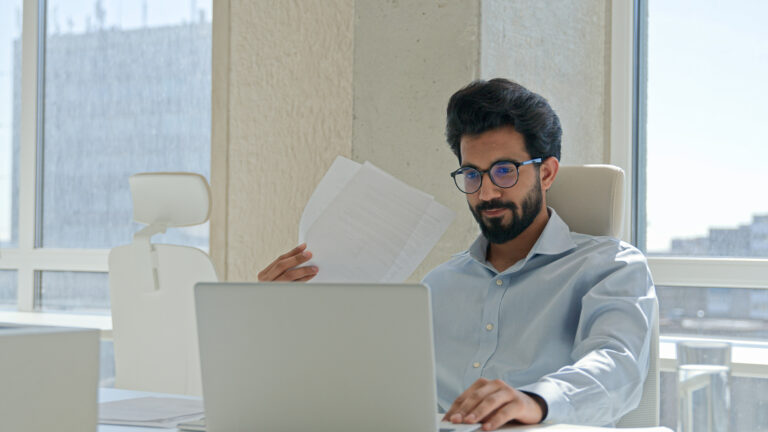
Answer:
[659,372,768,432]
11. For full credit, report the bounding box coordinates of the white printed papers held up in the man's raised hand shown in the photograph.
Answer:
[299,157,455,283]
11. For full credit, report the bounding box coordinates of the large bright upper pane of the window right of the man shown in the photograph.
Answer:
[646,0,768,257]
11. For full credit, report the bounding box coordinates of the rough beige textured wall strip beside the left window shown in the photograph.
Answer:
[217,0,354,280]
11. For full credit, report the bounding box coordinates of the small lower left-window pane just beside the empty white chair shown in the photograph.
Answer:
[37,271,110,315]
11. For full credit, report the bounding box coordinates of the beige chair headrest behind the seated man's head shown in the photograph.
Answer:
[547,165,624,238]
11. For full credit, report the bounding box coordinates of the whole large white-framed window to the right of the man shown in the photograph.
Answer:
[633,0,768,430]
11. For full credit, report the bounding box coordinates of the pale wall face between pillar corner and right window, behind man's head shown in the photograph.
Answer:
[481,0,611,164]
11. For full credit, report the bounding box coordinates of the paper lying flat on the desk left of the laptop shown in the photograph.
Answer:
[99,397,204,428]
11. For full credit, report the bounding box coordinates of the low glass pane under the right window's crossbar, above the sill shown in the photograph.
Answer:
[656,286,768,340]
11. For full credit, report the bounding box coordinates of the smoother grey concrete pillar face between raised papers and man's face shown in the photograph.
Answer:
[352,0,480,281]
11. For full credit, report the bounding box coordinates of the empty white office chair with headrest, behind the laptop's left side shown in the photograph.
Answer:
[109,173,218,395]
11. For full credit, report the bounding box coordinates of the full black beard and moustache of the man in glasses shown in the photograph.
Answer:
[469,178,542,244]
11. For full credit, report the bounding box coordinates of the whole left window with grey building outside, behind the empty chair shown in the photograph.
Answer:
[0,0,212,315]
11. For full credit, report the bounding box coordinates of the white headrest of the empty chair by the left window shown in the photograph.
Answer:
[128,172,211,227]
